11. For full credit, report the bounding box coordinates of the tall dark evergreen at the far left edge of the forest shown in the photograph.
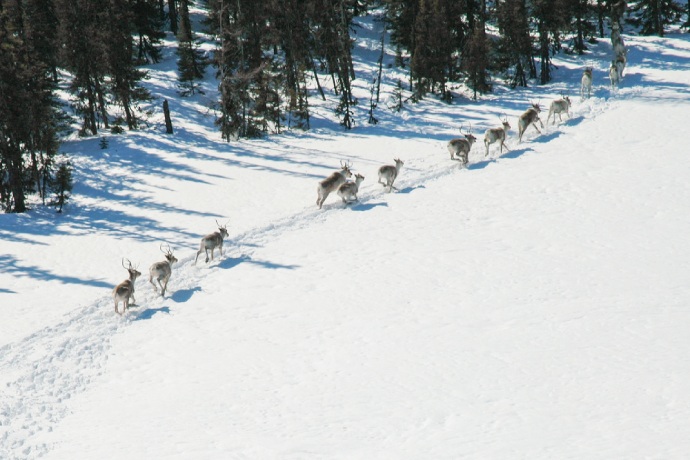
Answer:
[0,0,61,213]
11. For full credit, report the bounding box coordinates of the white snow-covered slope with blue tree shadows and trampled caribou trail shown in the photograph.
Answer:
[0,14,690,460]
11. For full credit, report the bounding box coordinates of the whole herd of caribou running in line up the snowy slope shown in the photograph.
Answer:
[113,0,627,315]
